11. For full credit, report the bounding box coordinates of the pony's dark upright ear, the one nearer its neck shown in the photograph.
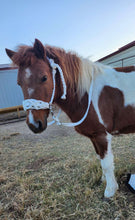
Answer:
[34,39,45,59]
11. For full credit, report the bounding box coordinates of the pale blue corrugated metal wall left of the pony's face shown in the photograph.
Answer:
[0,69,23,108]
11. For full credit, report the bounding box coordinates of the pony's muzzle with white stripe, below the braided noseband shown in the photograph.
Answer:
[26,110,47,133]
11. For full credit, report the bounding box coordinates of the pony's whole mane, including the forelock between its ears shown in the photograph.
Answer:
[13,45,105,97]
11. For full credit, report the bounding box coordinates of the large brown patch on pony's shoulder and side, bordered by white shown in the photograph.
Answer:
[99,86,135,134]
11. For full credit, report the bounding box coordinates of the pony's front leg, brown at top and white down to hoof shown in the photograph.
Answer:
[91,133,118,198]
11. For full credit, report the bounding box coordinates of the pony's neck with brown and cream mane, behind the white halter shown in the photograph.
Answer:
[52,49,105,121]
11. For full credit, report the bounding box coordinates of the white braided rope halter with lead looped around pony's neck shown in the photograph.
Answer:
[23,58,93,127]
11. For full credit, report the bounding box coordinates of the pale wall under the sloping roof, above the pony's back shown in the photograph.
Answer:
[101,46,135,67]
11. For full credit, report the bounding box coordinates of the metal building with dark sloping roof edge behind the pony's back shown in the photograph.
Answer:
[98,41,135,67]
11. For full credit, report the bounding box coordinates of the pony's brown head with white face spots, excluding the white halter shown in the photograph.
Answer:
[6,39,63,133]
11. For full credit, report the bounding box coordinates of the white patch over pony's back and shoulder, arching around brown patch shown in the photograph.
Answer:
[92,67,135,126]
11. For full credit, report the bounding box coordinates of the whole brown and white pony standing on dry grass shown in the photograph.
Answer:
[6,39,135,198]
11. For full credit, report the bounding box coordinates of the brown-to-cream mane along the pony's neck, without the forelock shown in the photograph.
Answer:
[45,46,106,97]
